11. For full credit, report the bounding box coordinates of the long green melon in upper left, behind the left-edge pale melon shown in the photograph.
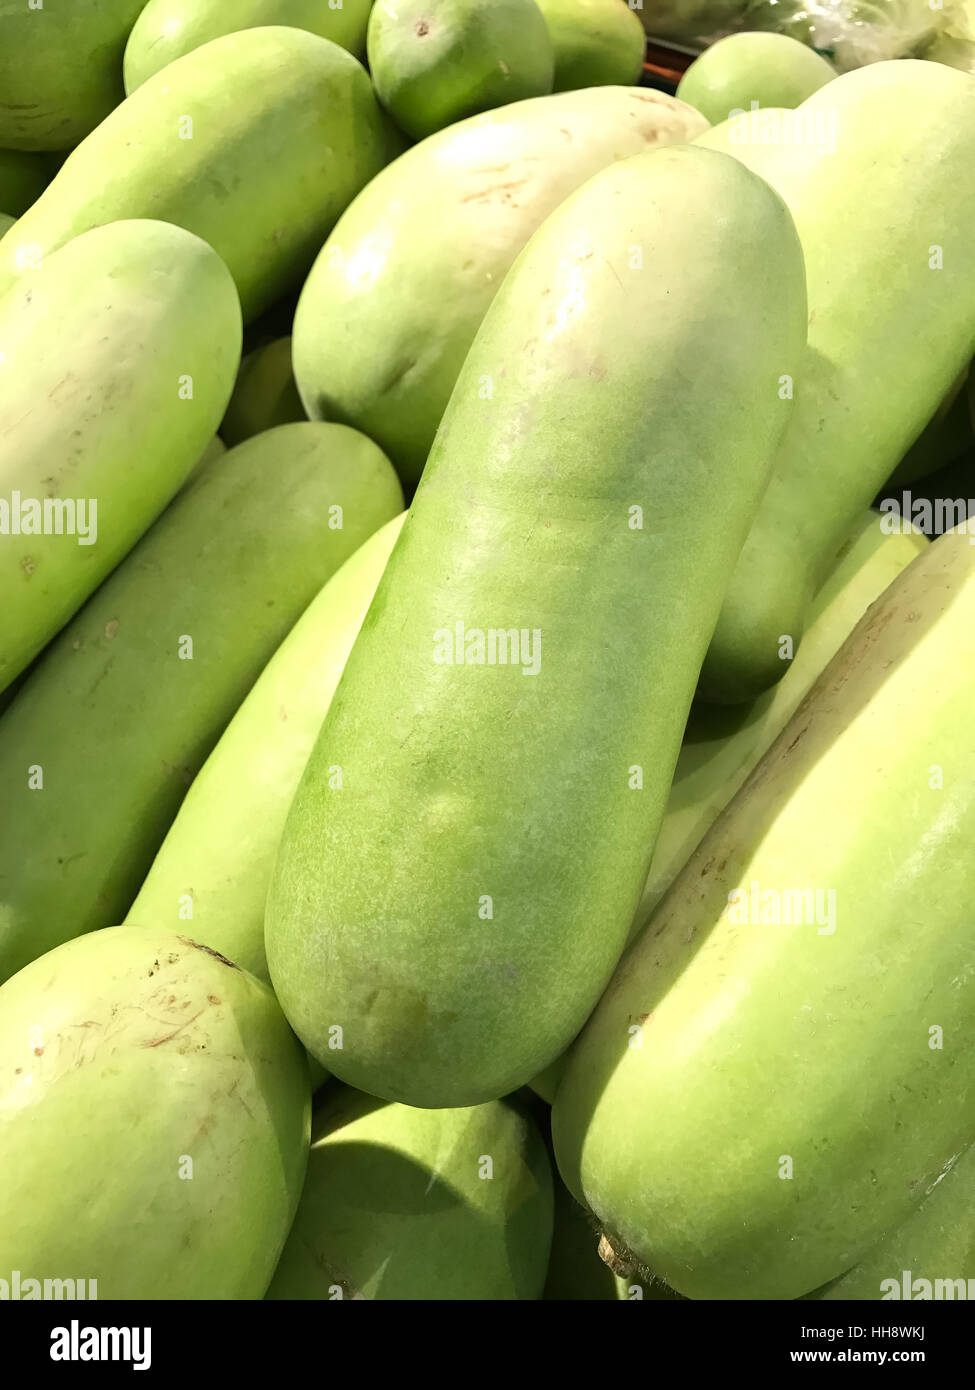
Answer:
[0,26,391,320]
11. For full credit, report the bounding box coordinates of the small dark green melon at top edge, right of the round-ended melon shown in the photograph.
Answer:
[537,0,647,92]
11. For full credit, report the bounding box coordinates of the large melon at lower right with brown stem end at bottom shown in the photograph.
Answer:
[552,532,975,1298]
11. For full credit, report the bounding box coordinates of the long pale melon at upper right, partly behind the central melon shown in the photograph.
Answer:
[692,61,975,702]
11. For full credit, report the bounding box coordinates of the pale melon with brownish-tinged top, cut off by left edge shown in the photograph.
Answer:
[0,218,241,689]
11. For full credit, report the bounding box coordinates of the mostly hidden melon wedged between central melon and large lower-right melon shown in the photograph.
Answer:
[530,512,928,1105]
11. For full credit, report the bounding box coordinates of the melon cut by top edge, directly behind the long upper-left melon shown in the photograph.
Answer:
[124,0,373,95]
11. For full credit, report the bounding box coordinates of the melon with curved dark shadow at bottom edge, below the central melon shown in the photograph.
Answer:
[267,1087,552,1301]
